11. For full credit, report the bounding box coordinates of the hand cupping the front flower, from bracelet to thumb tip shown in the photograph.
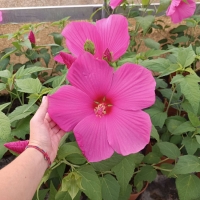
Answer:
[29,96,65,162]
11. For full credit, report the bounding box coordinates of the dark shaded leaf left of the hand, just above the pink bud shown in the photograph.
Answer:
[11,116,32,140]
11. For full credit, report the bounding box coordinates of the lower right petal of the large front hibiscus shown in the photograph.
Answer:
[106,107,151,156]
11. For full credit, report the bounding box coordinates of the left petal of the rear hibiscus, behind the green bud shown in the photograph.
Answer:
[62,22,102,58]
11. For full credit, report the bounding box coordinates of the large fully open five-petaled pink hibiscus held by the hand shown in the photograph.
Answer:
[48,53,155,162]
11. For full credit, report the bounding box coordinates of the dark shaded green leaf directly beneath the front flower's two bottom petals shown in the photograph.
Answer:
[91,153,123,172]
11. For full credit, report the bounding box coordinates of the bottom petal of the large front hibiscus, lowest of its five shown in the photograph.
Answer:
[74,114,114,162]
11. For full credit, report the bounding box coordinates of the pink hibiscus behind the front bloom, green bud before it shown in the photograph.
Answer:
[61,15,130,62]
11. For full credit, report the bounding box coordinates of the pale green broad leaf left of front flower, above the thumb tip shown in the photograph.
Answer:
[16,78,42,94]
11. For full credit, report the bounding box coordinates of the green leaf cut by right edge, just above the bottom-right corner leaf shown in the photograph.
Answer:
[171,155,200,174]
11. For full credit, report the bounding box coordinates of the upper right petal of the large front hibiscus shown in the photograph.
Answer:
[106,63,156,110]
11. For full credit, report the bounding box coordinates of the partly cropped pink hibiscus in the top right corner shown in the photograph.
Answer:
[166,0,196,23]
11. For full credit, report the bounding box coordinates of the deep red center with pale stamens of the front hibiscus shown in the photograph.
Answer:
[94,97,112,118]
